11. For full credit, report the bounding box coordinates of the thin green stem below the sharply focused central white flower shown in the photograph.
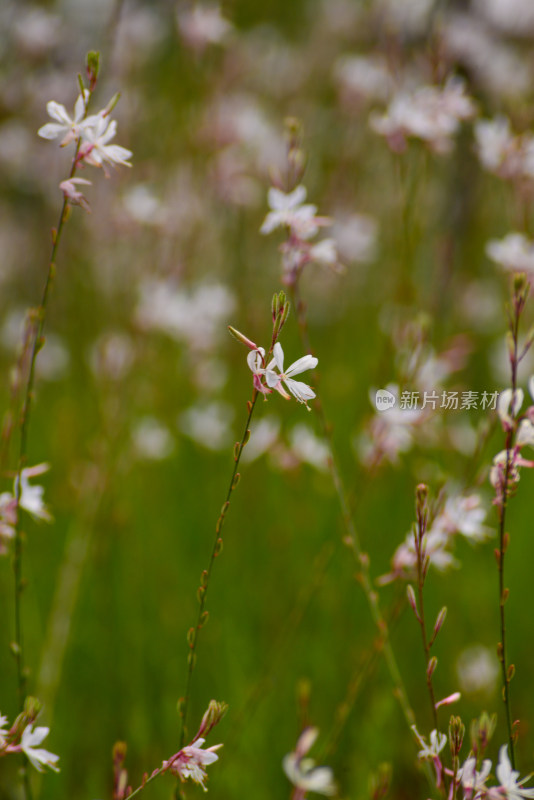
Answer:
[180,389,258,747]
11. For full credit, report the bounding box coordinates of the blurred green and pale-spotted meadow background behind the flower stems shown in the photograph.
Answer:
[0,0,534,800]
